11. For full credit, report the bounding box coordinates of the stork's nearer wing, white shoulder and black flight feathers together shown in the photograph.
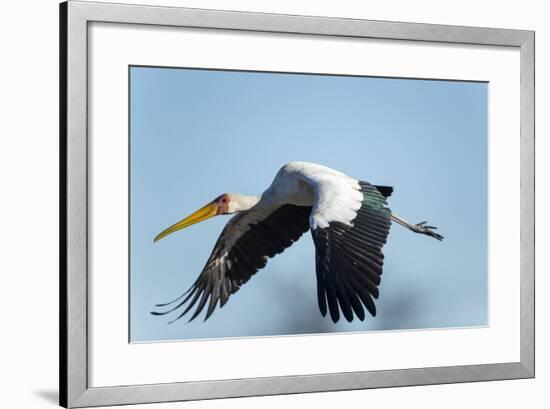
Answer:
[309,171,392,322]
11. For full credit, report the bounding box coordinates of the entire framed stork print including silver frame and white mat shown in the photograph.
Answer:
[60,1,534,407]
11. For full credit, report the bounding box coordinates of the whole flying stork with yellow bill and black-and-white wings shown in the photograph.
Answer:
[152,162,443,322]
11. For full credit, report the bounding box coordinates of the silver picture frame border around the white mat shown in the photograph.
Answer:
[60,1,535,408]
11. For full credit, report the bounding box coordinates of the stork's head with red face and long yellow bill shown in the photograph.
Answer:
[153,193,251,242]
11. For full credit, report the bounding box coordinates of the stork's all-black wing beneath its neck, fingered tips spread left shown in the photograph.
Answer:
[152,205,311,322]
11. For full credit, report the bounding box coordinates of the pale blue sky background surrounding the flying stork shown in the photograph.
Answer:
[130,67,488,341]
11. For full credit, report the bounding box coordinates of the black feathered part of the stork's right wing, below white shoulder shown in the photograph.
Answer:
[311,182,392,322]
